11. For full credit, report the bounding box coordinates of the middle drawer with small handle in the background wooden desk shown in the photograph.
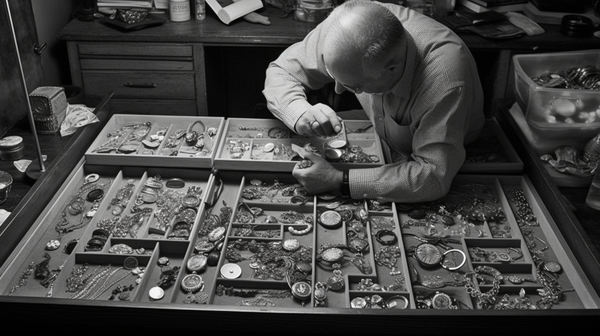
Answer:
[82,71,196,99]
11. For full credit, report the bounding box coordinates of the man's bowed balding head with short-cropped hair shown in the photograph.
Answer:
[324,0,404,73]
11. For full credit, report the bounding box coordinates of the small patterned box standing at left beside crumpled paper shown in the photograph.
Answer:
[29,86,69,134]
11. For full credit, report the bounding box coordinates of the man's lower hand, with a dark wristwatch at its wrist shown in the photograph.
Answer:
[292,152,344,195]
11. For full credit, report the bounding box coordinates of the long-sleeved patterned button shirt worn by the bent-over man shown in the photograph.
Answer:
[263,3,484,203]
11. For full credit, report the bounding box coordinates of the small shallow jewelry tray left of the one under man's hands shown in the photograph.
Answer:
[85,114,225,168]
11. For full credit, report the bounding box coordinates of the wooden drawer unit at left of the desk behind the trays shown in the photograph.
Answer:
[68,42,207,115]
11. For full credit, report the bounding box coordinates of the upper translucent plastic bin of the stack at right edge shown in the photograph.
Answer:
[513,50,600,138]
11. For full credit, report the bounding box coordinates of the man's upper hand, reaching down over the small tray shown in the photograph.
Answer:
[295,103,342,137]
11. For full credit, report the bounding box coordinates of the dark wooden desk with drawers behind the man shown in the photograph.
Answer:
[59,6,600,117]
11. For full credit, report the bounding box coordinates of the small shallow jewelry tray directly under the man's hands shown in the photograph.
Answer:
[215,118,385,172]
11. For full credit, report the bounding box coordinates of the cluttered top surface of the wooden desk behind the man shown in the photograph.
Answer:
[58,6,600,52]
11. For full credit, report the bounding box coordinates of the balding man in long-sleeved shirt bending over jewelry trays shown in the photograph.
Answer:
[263,0,484,203]
